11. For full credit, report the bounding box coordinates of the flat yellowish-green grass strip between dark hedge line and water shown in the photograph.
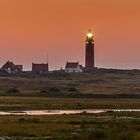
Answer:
[0,96,140,111]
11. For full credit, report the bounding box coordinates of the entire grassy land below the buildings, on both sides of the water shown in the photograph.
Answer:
[0,69,140,140]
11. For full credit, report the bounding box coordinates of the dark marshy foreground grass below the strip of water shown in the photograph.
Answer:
[0,113,140,140]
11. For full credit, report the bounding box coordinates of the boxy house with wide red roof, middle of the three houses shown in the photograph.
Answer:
[32,63,49,74]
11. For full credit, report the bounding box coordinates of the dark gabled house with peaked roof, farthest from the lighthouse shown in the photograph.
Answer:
[1,61,23,73]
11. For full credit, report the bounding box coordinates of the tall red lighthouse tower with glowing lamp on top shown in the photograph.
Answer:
[85,30,94,69]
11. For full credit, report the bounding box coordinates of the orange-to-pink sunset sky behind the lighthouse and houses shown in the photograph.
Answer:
[0,0,140,70]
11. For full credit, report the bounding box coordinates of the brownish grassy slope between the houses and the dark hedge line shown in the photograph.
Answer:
[0,69,140,95]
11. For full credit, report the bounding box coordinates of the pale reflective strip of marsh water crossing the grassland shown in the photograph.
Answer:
[0,109,140,115]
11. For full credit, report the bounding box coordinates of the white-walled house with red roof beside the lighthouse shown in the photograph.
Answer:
[65,62,83,73]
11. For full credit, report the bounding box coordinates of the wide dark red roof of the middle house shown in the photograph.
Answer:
[32,63,48,71]
